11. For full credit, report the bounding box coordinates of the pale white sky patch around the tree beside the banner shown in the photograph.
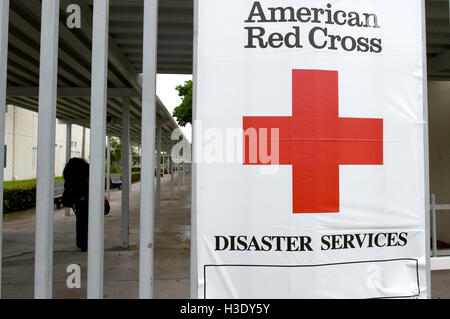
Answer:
[156,74,192,141]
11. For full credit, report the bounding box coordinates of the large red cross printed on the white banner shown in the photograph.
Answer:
[243,70,383,214]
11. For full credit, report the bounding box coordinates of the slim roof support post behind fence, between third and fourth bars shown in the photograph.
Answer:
[122,97,130,248]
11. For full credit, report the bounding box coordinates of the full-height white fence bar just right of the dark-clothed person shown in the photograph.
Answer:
[87,0,109,299]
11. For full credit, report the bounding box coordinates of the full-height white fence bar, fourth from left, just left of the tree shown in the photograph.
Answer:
[139,0,158,299]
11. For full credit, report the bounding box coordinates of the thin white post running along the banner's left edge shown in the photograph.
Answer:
[190,0,199,299]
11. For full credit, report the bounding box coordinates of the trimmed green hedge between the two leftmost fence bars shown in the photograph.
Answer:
[3,183,36,214]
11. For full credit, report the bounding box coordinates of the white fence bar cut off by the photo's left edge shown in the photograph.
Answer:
[0,0,9,298]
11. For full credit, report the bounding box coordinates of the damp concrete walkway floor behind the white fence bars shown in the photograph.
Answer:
[2,172,190,299]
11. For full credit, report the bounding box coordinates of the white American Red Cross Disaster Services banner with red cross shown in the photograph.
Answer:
[193,0,428,298]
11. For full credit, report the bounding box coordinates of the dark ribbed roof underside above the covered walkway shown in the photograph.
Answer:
[3,0,450,149]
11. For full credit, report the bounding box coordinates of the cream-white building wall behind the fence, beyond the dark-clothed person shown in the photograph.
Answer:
[5,105,89,181]
